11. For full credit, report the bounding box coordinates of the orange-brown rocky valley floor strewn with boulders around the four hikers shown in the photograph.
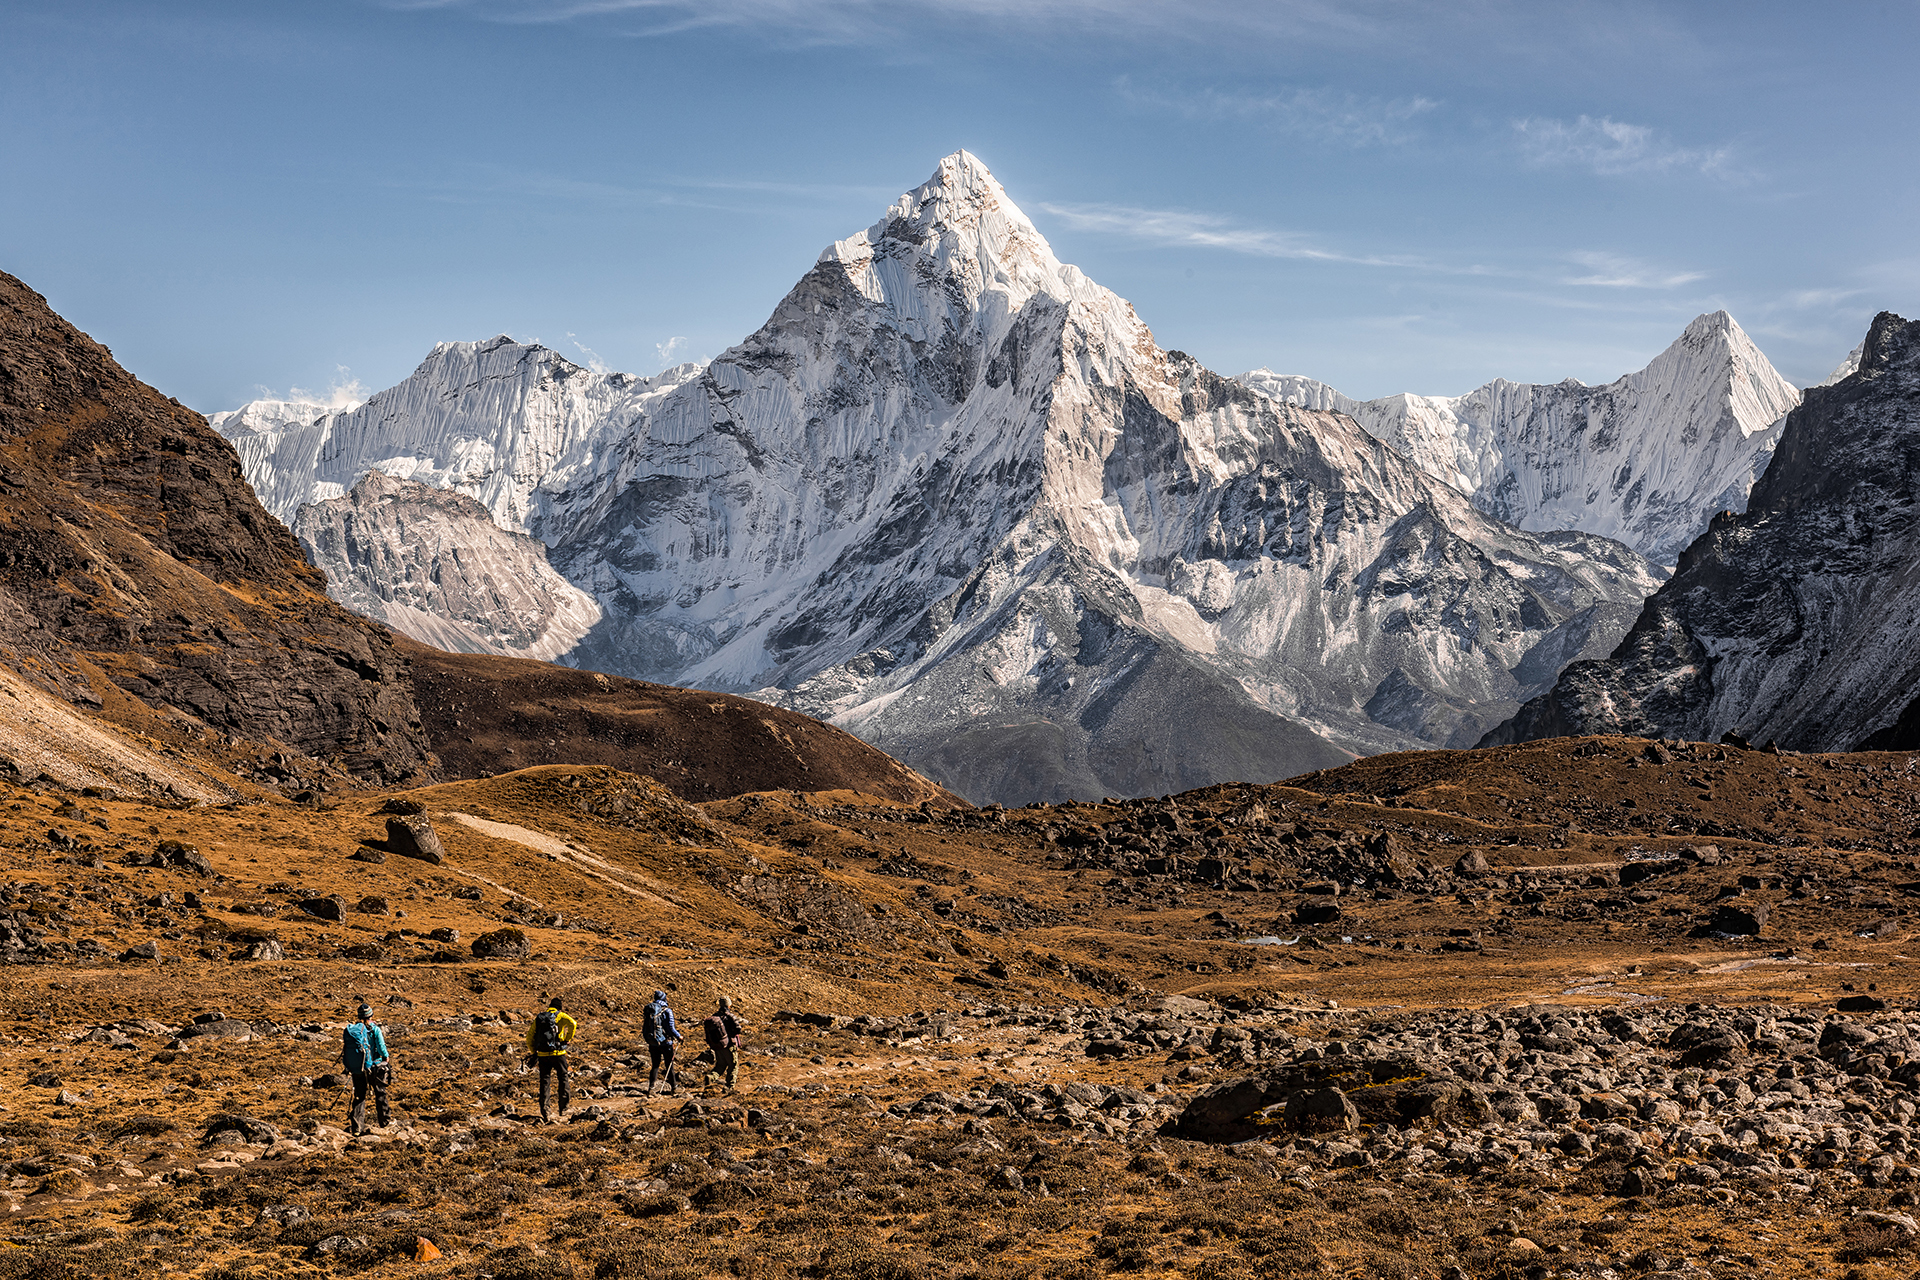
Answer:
[0,737,1920,1278]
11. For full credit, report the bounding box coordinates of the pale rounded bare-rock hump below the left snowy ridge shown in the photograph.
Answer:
[294,470,601,658]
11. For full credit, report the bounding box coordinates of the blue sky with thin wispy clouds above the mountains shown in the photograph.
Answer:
[0,0,1920,411]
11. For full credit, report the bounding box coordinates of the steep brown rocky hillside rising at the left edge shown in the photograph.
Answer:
[0,274,428,779]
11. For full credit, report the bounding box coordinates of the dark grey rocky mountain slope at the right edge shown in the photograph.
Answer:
[1486,313,1920,750]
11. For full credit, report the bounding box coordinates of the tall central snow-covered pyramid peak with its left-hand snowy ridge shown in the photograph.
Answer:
[220,152,1659,802]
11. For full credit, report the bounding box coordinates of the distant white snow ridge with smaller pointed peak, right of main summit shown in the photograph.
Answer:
[1240,311,1799,564]
